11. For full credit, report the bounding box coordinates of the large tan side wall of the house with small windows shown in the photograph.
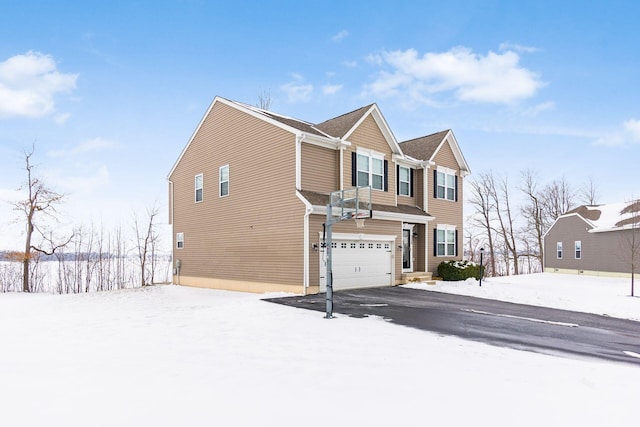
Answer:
[170,103,304,286]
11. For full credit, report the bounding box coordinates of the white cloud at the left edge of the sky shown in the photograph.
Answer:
[0,51,78,120]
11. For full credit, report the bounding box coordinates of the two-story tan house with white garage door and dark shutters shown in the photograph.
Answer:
[168,97,469,293]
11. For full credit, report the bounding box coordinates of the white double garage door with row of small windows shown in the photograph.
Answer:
[320,239,393,292]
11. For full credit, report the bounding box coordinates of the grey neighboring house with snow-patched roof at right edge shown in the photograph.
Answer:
[544,201,640,276]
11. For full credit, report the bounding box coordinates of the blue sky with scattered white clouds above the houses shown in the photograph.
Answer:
[0,0,640,248]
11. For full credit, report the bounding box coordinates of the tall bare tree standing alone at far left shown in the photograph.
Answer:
[14,146,71,292]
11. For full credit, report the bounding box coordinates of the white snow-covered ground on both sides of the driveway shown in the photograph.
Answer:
[0,275,640,426]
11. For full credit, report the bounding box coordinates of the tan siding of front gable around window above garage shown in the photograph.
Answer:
[344,116,396,206]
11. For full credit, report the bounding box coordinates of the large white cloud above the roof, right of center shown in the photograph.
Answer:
[365,47,545,104]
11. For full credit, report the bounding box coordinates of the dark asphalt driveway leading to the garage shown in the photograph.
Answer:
[266,287,640,365]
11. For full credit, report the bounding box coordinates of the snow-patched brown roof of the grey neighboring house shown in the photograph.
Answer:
[549,200,640,233]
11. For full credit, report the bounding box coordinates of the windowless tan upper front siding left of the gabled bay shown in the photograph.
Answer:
[301,142,340,194]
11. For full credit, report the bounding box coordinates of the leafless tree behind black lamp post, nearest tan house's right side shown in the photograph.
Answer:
[470,173,496,275]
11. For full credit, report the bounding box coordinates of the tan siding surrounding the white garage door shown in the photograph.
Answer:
[309,215,402,286]
